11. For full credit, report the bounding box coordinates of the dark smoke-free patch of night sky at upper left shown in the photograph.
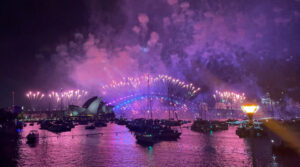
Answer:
[0,0,89,106]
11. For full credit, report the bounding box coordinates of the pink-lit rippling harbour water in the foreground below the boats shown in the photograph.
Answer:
[11,124,300,167]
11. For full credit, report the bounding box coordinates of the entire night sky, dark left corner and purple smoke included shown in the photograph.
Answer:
[0,0,300,107]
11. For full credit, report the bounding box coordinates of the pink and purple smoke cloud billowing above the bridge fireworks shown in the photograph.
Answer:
[38,0,300,102]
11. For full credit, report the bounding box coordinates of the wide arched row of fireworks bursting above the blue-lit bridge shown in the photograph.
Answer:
[101,75,200,98]
